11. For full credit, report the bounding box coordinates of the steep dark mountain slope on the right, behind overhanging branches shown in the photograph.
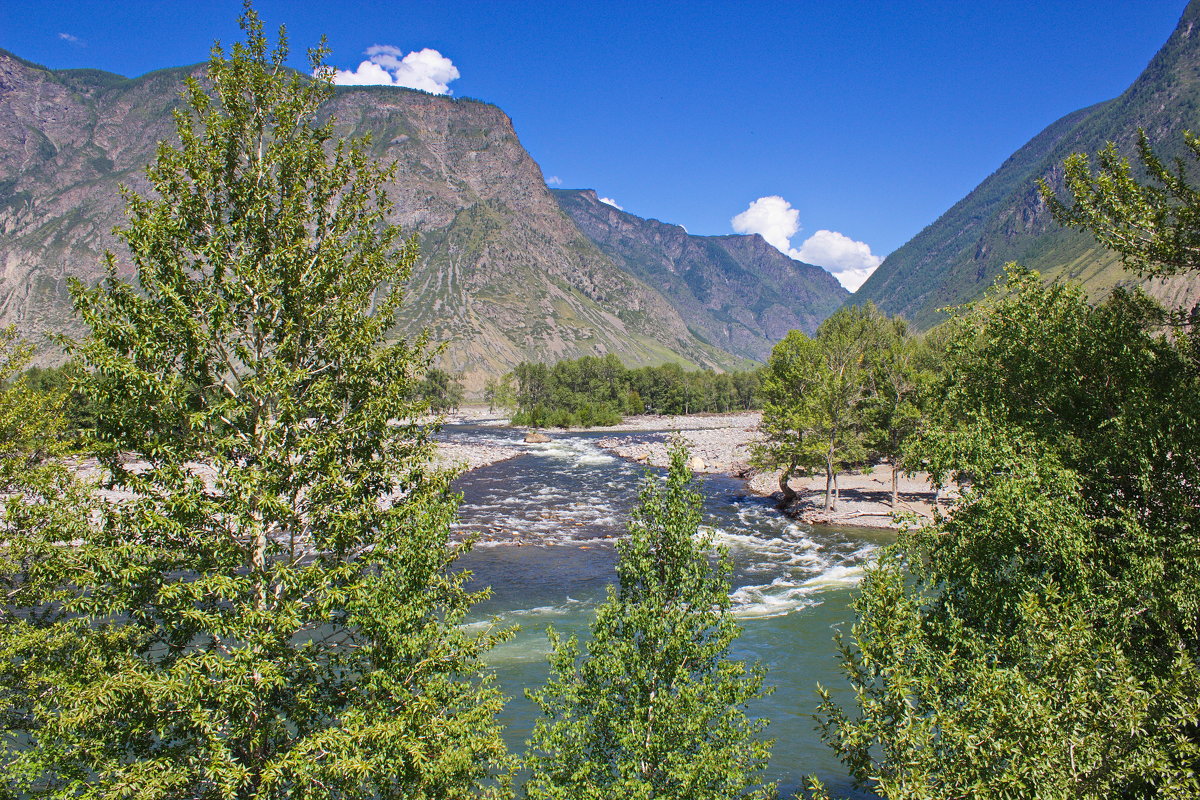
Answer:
[852,0,1200,327]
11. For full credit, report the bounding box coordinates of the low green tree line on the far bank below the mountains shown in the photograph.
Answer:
[512,353,760,428]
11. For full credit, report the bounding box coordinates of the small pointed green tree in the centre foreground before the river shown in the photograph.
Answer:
[526,443,770,800]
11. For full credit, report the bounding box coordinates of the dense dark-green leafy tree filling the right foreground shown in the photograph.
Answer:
[822,269,1200,798]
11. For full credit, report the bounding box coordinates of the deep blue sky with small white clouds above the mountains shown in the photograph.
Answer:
[0,0,1186,288]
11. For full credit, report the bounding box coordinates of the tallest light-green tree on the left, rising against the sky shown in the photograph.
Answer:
[2,6,506,798]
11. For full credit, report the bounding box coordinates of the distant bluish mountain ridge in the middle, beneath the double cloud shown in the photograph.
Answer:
[553,190,850,361]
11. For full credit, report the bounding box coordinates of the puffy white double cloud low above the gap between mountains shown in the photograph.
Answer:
[730,194,883,291]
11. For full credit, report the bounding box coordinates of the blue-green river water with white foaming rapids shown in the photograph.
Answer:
[443,425,892,794]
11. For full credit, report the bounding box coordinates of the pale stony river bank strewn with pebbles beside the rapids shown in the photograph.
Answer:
[438,407,954,528]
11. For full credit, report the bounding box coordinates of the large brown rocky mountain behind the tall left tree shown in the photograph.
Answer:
[0,50,743,390]
